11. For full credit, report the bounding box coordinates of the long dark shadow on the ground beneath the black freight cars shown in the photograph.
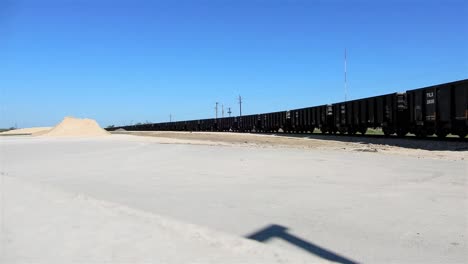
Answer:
[268,133,468,151]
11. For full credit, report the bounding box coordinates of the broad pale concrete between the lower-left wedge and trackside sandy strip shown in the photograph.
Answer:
[0,135,468,263]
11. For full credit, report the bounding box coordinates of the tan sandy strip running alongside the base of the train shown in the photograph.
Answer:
[114,131,468,160]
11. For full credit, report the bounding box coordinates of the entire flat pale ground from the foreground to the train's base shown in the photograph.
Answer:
[0,133,468,263]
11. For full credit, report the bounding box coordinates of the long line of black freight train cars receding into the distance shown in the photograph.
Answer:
[109,79,468,138]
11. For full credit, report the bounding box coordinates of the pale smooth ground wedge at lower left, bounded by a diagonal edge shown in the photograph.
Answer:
[0,176,322,263]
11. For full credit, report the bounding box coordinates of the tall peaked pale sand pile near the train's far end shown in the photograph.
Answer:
[42,117,110,137]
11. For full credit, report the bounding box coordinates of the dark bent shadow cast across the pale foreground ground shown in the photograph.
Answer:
[246,225,358,264]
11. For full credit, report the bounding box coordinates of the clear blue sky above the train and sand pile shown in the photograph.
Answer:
[0,0,468,127]
